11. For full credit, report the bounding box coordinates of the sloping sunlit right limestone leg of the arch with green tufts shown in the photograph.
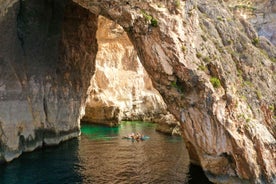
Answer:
[76,0,276,183]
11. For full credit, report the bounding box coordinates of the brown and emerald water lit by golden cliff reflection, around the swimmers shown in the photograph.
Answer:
[79,122,189,183]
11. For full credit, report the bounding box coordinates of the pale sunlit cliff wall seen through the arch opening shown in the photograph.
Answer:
[82,16,166,125]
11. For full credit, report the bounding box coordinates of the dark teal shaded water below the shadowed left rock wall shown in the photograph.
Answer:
[0,138,82,184]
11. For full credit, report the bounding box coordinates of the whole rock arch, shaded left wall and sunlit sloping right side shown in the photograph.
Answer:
[0,0,276,183]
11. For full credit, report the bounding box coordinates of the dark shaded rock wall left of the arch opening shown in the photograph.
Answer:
[0,0,97,161]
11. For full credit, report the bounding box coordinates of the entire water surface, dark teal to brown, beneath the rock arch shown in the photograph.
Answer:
[0,122,212,184]
